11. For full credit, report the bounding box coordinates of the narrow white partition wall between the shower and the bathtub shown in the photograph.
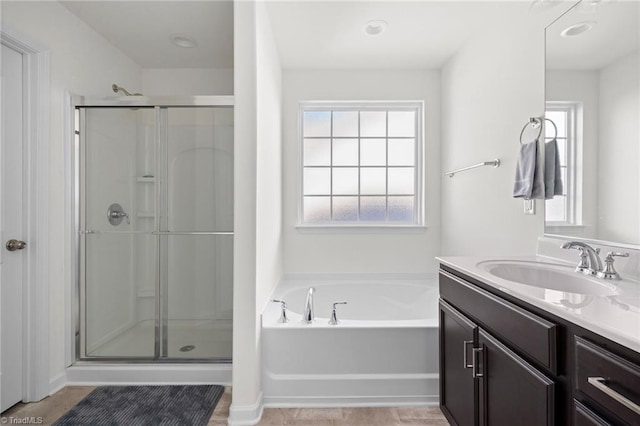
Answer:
[229,2,283,424]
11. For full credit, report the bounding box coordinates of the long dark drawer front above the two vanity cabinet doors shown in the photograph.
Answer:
[440,271,558,374]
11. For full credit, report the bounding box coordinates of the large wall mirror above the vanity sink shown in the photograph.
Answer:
[545,0,640,246]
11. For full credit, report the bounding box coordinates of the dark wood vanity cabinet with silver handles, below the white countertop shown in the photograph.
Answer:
[439,266,640,426]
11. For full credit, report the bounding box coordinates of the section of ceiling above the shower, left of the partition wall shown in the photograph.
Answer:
[60,0,233,68]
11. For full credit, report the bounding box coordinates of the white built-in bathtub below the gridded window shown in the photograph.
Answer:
[262,277,439,407]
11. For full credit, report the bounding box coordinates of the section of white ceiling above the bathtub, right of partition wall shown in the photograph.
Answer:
[267,0,531,69]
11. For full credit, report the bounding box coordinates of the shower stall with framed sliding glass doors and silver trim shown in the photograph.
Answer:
[74,96,233,362]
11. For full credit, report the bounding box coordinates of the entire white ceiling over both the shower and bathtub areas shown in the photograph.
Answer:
[60,0,588,69]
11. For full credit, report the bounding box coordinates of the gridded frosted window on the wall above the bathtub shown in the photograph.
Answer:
[300,102,422,226]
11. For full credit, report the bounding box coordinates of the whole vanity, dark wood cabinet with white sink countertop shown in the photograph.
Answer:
[439,257,640,426]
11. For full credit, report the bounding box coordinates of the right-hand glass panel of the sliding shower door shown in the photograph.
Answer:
[160,107,233,359]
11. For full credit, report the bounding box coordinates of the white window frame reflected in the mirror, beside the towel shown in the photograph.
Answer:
[545,101,583,227]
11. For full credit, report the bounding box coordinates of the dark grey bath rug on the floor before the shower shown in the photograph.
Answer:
[53,385,224,426]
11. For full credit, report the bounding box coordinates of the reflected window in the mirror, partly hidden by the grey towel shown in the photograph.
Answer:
[545,102,581,226]
